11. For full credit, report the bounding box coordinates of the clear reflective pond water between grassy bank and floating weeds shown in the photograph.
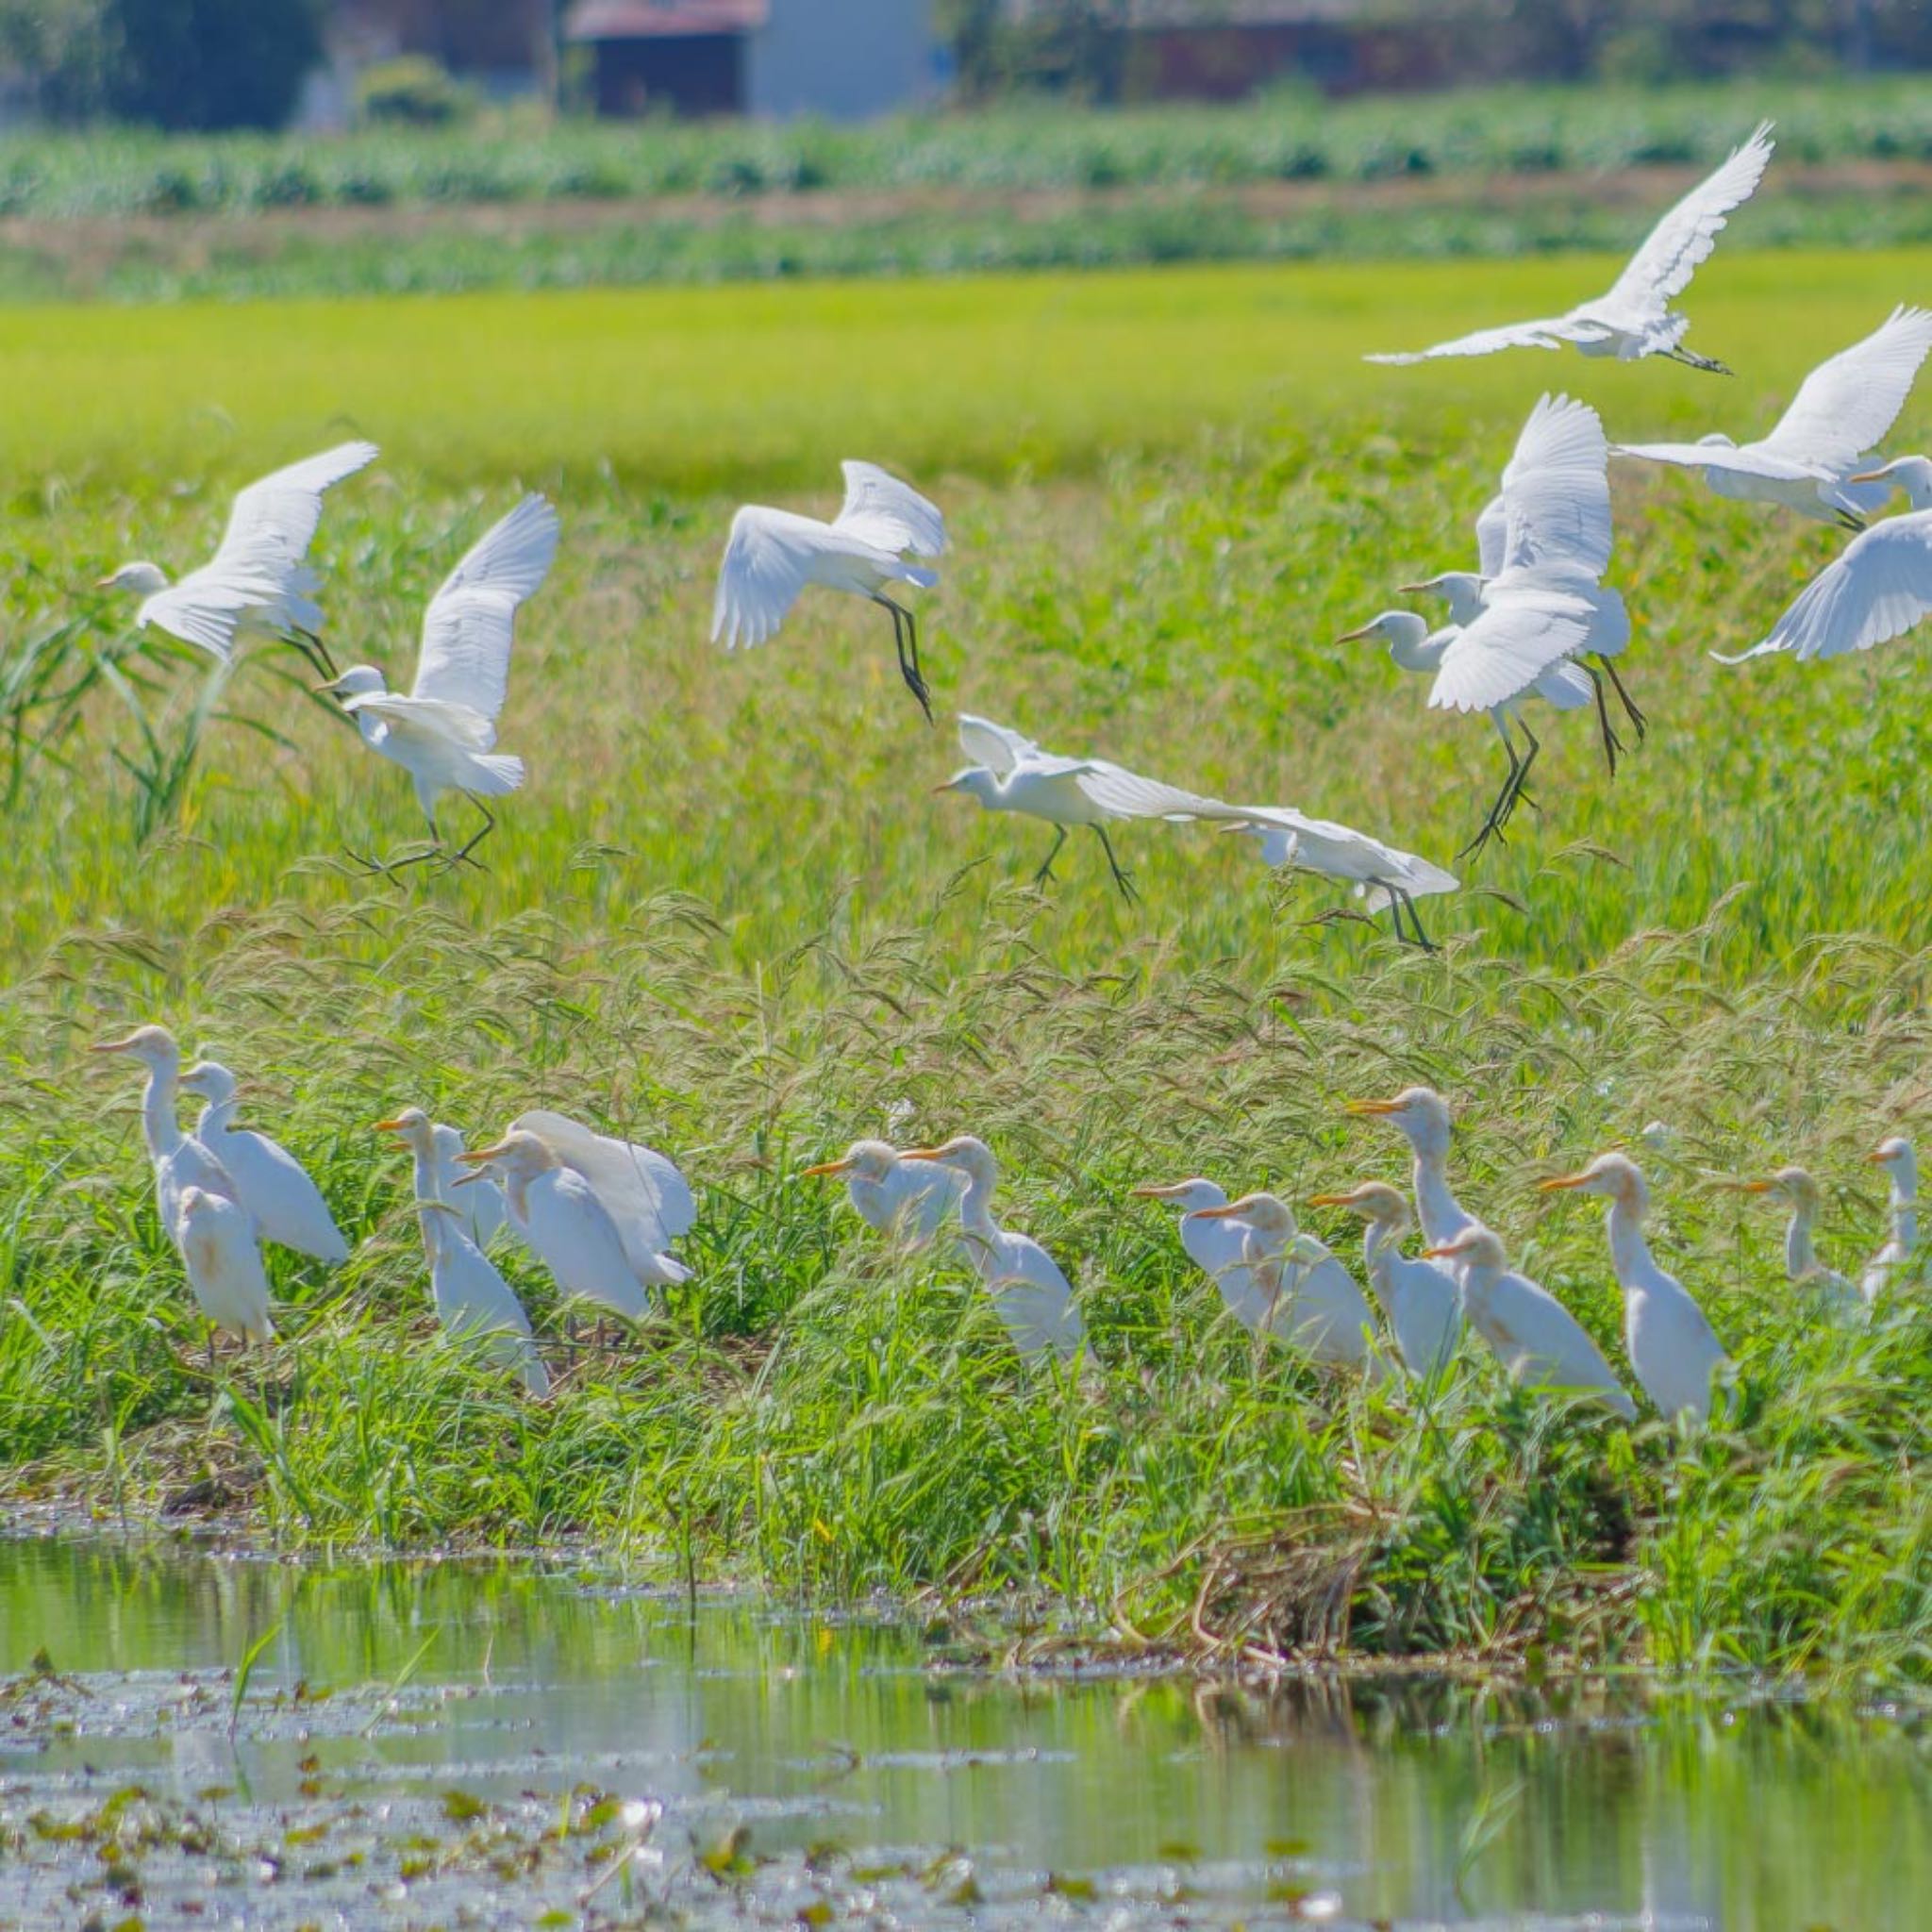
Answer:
[0,1541,1932,1928]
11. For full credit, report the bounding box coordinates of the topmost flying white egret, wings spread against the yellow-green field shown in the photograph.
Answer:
[1364,122,1772,375]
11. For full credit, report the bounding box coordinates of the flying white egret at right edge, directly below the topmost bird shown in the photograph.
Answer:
[1611,304,1932,529]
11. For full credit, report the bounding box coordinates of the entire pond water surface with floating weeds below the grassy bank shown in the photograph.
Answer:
[0,1540,1932,1928]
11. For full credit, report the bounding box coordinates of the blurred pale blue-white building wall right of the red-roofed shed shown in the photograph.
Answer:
[746,0,939,120]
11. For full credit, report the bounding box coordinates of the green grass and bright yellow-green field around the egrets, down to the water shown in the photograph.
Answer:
[0,257,1932,1679]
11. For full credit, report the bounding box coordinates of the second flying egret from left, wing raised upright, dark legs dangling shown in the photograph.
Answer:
[323,496,557,870]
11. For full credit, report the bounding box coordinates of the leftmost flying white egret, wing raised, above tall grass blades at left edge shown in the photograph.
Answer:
[94,442,378,676]
